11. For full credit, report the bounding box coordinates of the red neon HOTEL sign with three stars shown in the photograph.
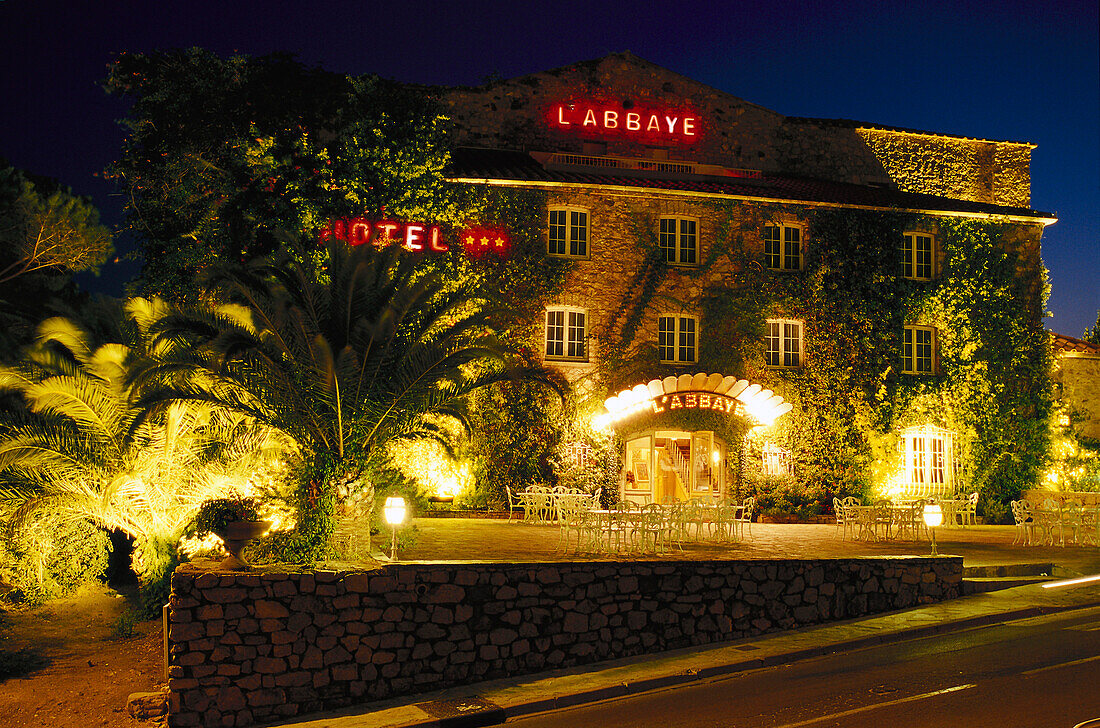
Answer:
[317,218,509,255]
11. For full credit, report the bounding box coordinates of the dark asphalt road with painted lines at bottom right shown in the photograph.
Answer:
[508,608,1100,728]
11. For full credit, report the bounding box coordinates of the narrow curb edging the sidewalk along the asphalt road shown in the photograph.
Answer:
[402,599,1100,728]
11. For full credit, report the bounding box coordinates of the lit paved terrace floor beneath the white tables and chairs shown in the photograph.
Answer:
[396,518,1100,574]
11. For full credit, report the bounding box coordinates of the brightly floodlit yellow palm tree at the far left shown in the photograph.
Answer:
[0,298,288,611]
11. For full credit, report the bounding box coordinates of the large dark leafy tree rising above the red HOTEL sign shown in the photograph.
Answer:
[106,48,469,299]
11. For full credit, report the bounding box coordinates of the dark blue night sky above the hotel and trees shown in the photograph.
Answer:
[0,0,1100,337]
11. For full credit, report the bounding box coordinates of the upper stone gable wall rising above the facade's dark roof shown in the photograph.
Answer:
[433,53,1033,207]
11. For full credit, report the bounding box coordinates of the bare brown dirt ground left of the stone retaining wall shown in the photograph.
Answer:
[0,585,165,728]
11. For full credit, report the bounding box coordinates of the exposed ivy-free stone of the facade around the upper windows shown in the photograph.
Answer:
[531,188,1044,396]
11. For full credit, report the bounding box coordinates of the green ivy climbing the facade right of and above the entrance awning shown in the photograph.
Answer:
[512,193,1051,521]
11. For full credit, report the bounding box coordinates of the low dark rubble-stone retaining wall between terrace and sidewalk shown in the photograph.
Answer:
[168,556,963,727]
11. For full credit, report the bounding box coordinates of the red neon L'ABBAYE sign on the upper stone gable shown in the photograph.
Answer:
[549,100,700,143]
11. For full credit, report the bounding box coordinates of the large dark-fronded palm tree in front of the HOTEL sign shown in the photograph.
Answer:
[139,243,562,559]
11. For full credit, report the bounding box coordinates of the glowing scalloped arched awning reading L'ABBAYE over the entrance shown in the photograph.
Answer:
[592,372,793,430]
